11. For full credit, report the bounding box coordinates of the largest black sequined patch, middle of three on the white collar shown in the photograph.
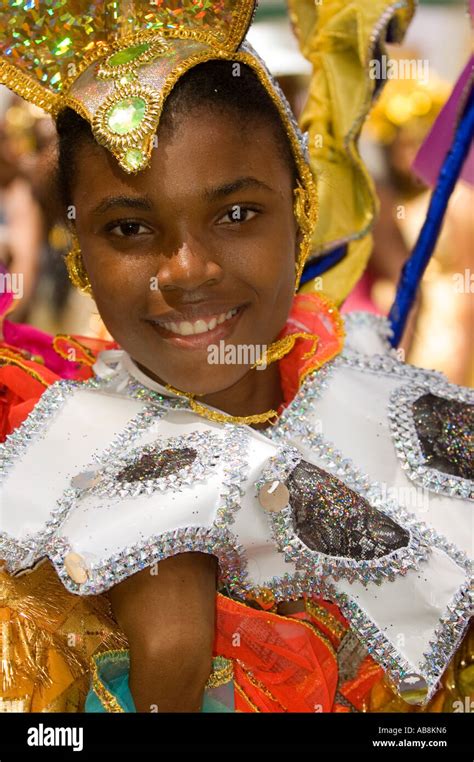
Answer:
[286,460,410,561]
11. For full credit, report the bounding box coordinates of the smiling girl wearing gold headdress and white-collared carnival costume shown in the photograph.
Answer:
[2,2,472,712]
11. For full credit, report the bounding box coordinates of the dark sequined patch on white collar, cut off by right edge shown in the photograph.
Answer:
[413,394,474,479]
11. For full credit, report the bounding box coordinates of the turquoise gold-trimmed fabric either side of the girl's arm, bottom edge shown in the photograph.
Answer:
[84,651,235,714]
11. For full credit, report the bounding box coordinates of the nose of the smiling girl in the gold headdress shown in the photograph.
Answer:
[156,237,223,291]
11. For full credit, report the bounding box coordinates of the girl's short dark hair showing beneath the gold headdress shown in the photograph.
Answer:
[56,61,298,208]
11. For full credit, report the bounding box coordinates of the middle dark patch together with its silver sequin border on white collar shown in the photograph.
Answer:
[255,446,430,584]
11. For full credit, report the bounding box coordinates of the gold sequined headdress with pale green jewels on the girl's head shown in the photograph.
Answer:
[0,0,317,294]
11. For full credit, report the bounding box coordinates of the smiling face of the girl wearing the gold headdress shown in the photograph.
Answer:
[73,109,299,394]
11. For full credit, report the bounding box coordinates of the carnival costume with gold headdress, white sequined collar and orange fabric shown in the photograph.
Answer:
[0,0,474,712]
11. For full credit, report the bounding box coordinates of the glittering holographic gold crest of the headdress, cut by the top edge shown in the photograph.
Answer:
[0,0,254,92]
